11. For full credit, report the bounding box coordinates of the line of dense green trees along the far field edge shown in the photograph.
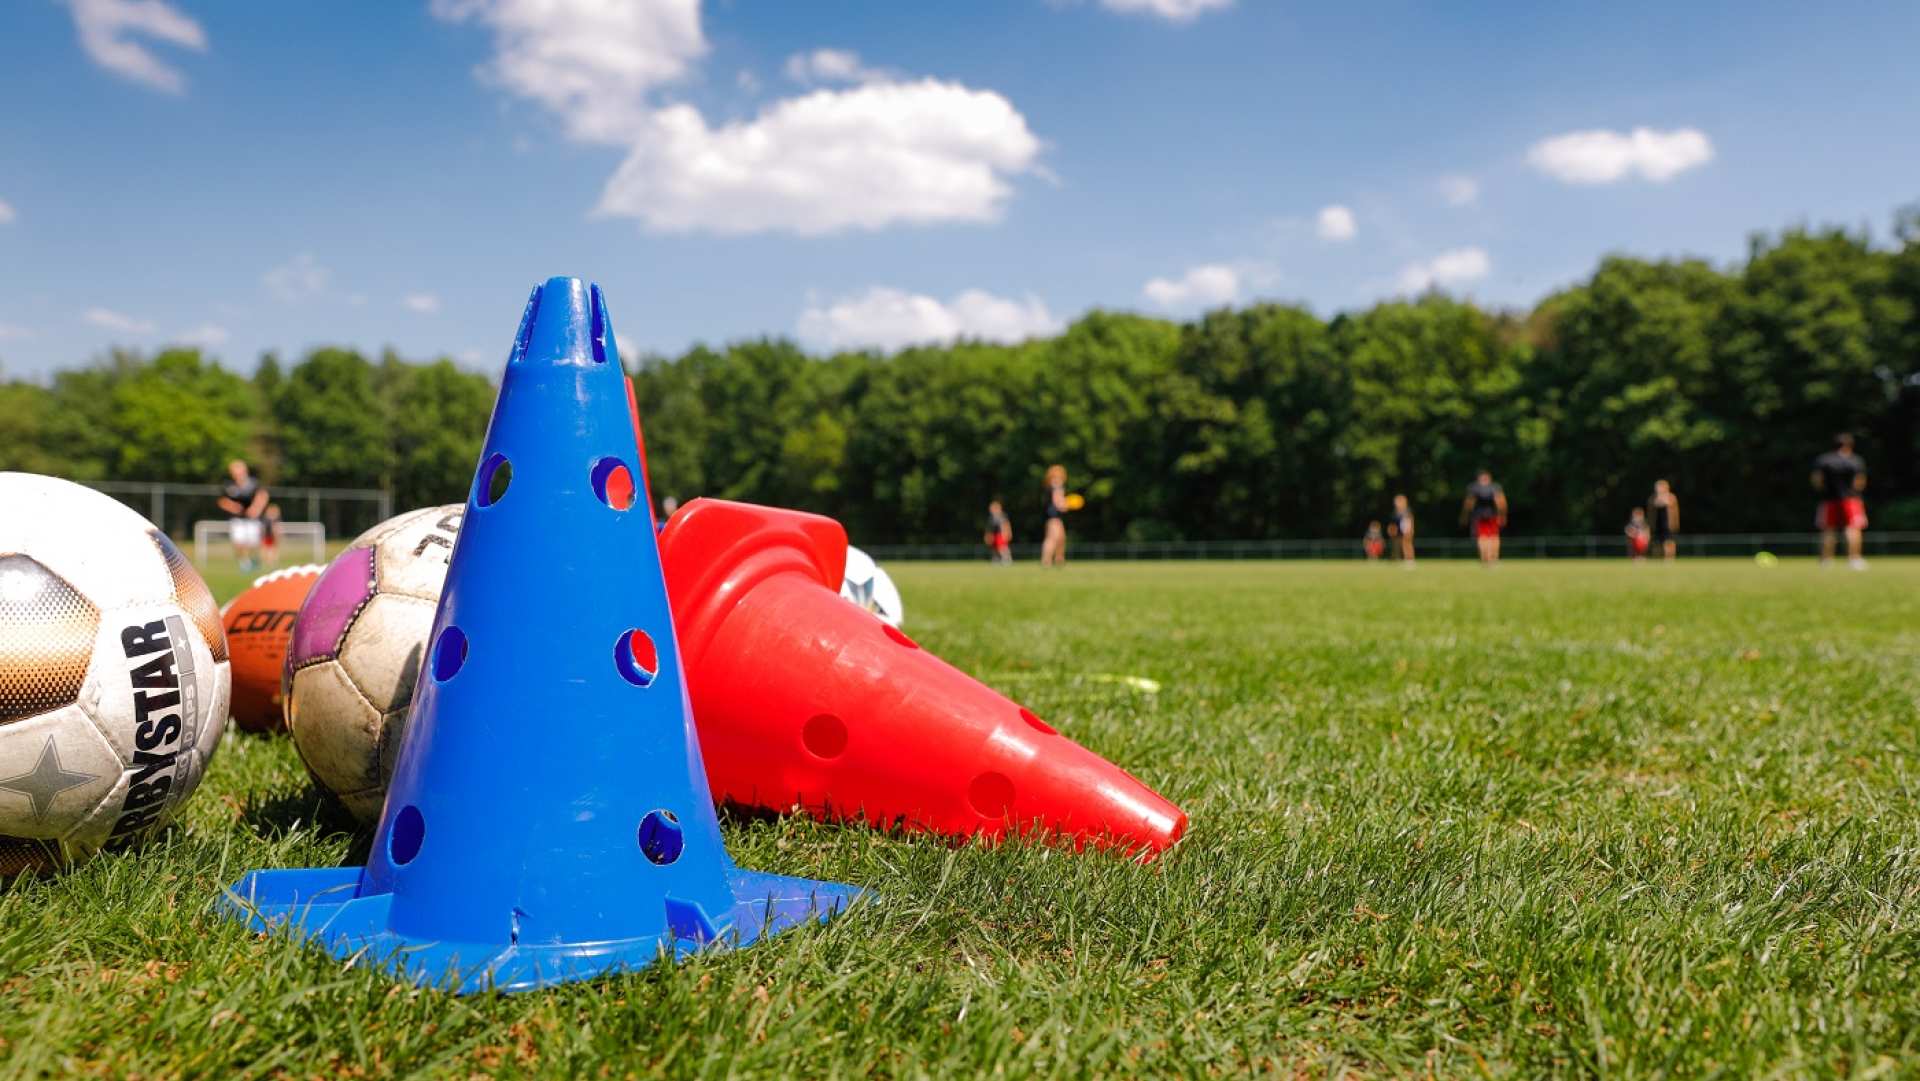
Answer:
[0,207,1920,543]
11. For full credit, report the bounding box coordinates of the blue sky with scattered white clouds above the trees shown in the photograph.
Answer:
[0,0,1920,376]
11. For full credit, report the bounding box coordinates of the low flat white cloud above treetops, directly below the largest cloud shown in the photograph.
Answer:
[799,286,1060,349]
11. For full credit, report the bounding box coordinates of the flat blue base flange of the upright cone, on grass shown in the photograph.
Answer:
[221,868,862,995]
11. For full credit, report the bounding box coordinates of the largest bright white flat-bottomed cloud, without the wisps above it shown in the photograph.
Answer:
[599,79,1041,236]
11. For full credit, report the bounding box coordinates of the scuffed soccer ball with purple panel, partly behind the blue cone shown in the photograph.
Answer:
[282,503,467,822]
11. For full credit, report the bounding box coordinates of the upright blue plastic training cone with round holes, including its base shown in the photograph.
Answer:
[227,278,860,993]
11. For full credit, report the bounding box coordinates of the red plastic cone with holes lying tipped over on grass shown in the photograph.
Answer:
[660,499,1187,856]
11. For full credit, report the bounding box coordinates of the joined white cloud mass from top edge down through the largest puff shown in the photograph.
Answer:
[432,0,1041,234]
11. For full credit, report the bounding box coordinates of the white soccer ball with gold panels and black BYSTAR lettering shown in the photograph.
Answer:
[0,472,230,877]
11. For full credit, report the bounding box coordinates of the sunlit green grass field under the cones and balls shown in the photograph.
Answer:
[0,561,1920,1077]
